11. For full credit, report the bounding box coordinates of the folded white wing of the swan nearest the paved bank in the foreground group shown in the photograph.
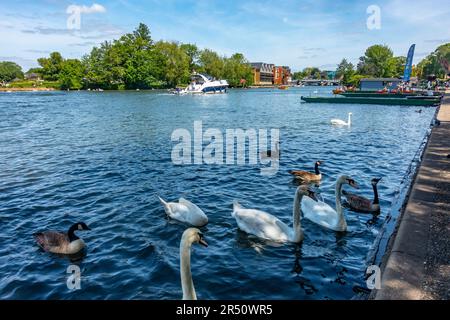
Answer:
[301,196,338,229]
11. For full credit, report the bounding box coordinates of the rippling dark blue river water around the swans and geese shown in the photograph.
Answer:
[0,88,435,299]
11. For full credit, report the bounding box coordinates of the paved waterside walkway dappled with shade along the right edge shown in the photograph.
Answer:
[372,93,450,300]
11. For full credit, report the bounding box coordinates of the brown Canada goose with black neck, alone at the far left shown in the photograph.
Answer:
[33,222,91,254]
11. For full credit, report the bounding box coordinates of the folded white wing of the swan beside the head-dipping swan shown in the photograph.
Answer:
[234,208,290,241]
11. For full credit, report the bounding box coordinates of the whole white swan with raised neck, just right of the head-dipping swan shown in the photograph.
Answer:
[231,186,314,243]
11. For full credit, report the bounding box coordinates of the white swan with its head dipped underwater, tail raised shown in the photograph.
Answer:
[158,197,208,227]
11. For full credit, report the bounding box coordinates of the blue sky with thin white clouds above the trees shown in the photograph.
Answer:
[0,0,450,70]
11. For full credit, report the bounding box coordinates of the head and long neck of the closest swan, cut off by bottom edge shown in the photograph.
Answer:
[180,228,208,300]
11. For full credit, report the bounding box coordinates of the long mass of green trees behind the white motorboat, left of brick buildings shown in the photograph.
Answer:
[0,23,253,90]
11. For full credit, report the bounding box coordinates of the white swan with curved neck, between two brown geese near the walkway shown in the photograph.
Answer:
[301,176,358,231]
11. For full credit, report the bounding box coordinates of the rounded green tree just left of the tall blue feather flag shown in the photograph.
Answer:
[357,45,395,77]
